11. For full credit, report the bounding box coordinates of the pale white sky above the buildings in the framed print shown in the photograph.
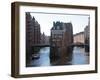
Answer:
[31,12,89,36]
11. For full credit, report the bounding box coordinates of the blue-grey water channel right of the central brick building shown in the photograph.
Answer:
[71,47,89,65]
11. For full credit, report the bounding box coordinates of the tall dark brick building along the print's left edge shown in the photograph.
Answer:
[26,12,41,62]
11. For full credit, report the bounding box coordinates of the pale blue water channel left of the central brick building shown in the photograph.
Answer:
[30,47,50,66]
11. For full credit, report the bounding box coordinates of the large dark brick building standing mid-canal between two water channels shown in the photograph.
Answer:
[50,22,73,64]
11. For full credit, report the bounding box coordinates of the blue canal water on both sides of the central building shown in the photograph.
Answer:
[28,47,89,67]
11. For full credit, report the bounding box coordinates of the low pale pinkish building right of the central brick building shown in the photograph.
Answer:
[74,32,84,44]
